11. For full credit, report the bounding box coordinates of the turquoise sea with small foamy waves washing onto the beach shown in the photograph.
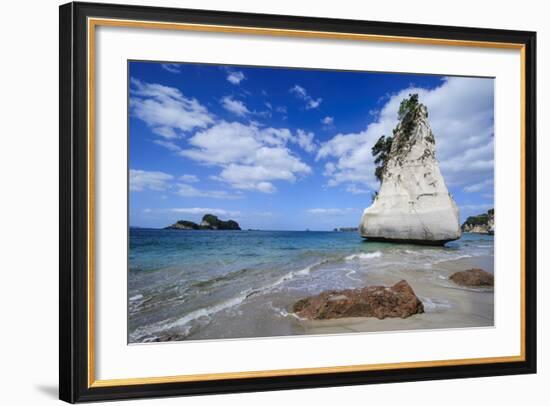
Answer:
[128,229,493,343]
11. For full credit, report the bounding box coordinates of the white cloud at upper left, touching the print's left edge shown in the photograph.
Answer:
[130,78,214,139]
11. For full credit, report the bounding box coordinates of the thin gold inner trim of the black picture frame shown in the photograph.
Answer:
[87,18,526,388]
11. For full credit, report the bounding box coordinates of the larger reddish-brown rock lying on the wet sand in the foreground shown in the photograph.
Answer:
[293,280,424,320]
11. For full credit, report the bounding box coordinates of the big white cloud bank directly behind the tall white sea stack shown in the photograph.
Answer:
[317,77,494,195]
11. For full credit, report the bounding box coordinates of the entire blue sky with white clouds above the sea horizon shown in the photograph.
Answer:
[129,62,494,230]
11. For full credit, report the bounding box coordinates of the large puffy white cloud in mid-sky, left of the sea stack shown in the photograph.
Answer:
[180,121,311,193]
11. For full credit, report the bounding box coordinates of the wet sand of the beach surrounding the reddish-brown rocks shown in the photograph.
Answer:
[181,256,494,341]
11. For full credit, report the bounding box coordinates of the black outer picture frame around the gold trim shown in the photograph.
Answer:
[59,3,536,403]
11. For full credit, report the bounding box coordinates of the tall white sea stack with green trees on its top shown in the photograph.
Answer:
[359,94,461,245]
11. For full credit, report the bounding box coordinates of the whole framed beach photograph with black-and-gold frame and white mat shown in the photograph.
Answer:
[60,3,536,402]
